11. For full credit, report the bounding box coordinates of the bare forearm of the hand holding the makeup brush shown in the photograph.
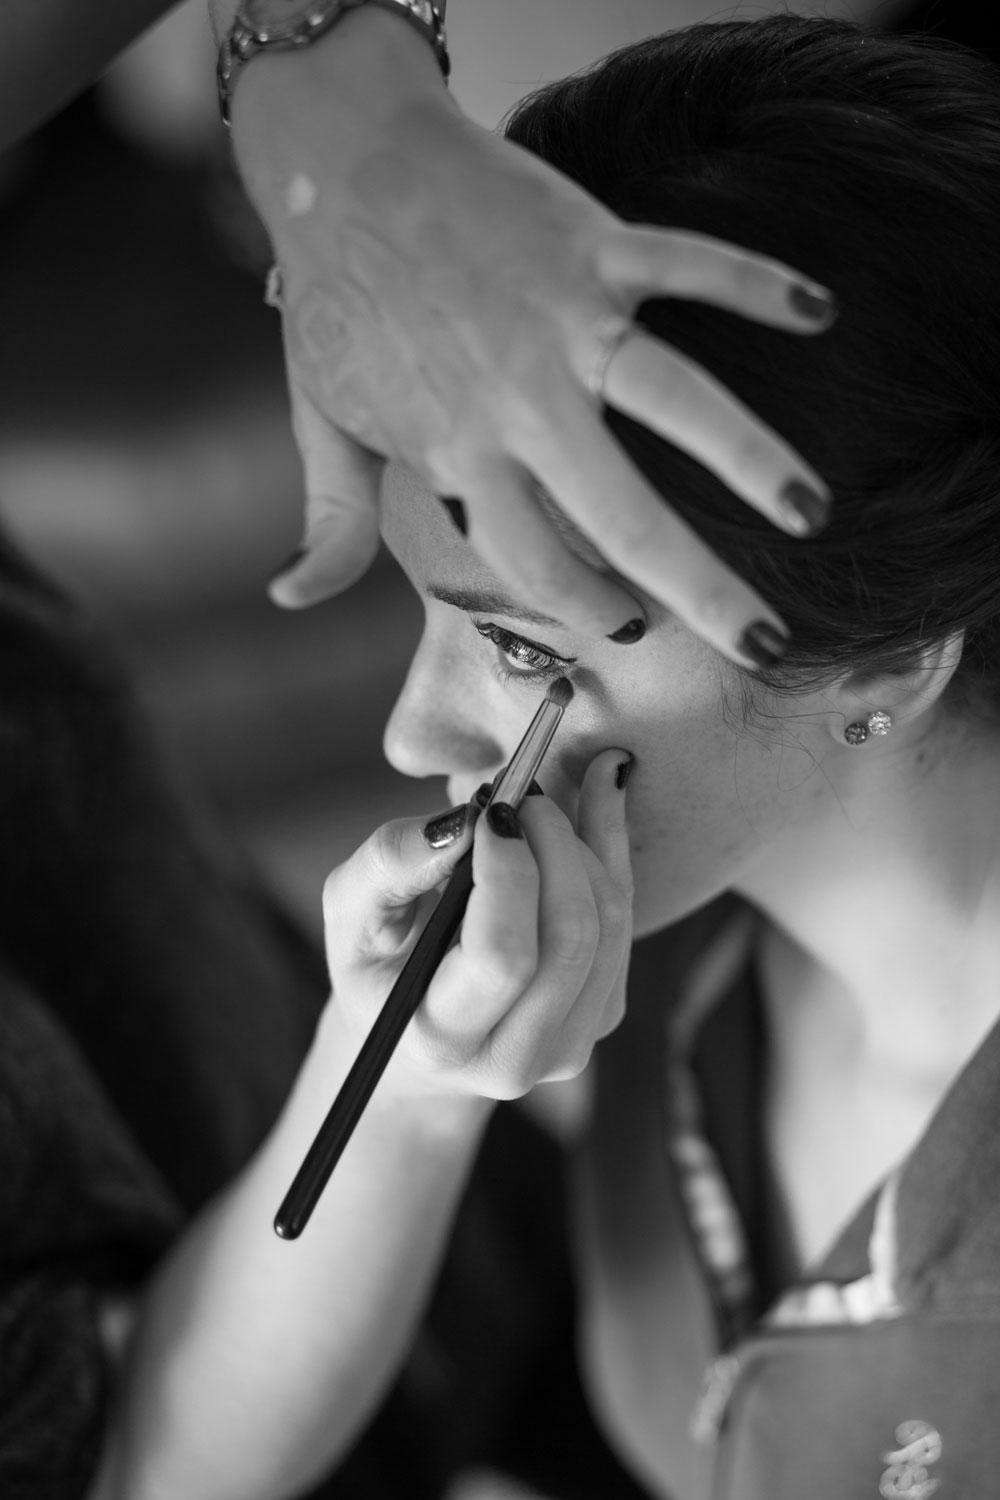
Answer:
[93,1013,489,1500]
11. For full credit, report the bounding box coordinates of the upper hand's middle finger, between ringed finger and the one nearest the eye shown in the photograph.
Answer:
[532,401,787,668]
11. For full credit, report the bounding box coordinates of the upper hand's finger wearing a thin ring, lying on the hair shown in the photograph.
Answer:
[603,327,831,536]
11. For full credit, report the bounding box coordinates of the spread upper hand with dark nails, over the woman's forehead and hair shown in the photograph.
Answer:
[220,6,831,665]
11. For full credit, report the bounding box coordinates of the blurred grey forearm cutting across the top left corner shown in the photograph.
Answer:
[0,0,177,150]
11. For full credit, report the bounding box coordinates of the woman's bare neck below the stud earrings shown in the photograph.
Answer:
[739,722,1000,1089]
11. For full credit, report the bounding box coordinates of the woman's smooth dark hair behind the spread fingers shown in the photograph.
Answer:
[505,15,1000,716]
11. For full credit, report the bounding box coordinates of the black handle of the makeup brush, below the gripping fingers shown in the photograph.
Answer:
[274,849,472,1239]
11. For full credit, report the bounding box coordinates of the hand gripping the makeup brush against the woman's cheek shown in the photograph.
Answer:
[324,750,631,1100]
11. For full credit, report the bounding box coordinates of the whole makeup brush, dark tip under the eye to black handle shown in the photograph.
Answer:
[274,677,573,1239]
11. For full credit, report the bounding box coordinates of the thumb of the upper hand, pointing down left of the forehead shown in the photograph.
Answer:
[268,374,385,609]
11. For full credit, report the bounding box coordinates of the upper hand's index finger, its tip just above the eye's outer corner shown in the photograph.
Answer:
[452,461,642,636]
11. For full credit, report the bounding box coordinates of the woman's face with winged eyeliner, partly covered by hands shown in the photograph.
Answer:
[382,471,831,935]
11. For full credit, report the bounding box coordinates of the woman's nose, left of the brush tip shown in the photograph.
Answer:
[382,630,504,777]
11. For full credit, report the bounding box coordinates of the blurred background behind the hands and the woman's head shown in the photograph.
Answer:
[0,0,994,932]
